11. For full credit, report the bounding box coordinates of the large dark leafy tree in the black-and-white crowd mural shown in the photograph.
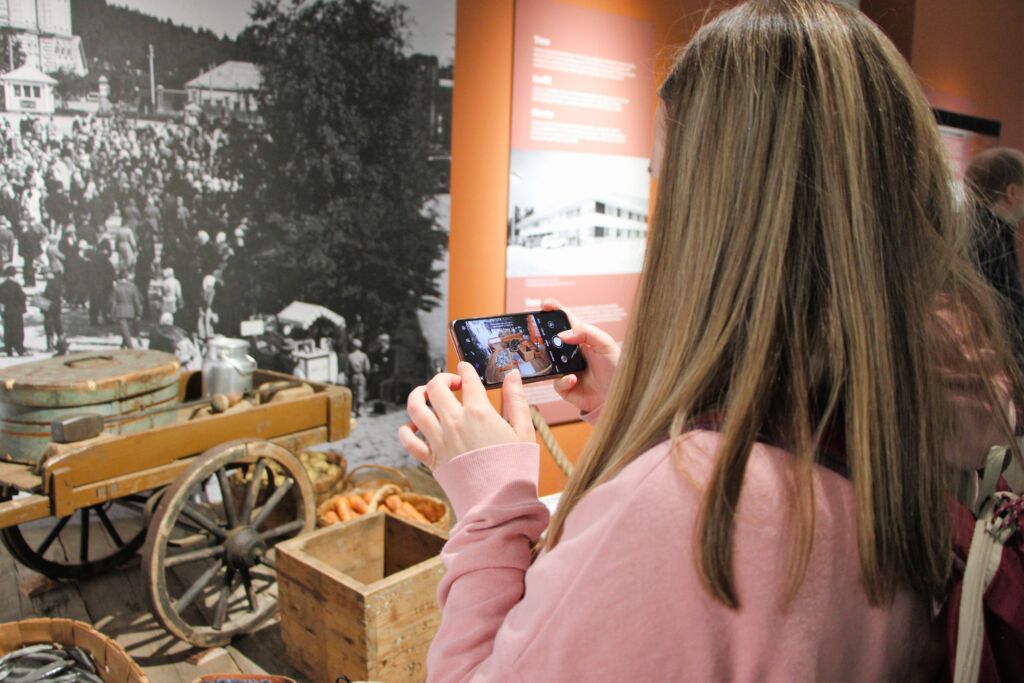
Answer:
[225,0,447,374]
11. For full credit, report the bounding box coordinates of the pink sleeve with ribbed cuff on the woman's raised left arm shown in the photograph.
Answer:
[427,443,548,682]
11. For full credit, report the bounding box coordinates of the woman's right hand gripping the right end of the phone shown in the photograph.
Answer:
[543,299,621,413]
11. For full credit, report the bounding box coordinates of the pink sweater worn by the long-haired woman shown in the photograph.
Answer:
[428,431,942,683]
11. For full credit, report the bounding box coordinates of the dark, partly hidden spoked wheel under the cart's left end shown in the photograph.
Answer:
[0,494,148,579]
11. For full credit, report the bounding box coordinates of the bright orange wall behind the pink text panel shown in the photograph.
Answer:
[449,0,706,494]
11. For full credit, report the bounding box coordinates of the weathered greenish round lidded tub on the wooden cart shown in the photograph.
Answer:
[0,350,179,463]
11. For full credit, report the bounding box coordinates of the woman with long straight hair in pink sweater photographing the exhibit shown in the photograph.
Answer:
[399,0,1019,681]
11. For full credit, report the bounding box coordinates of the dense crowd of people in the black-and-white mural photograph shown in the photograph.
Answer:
[0,109,248,354]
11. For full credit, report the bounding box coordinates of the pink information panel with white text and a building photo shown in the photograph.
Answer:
[505,0,654,423]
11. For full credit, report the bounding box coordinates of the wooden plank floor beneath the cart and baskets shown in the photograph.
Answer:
[0,468,443,683]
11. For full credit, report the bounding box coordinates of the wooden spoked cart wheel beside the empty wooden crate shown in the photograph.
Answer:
[142,441,315,647]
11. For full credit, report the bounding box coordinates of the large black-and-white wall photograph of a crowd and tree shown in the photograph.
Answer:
[0,0,455,459]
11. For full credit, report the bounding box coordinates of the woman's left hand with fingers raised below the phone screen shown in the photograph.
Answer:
[398,362,536,469]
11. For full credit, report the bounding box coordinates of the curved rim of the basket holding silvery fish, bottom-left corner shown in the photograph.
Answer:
[0,618,150,683]
